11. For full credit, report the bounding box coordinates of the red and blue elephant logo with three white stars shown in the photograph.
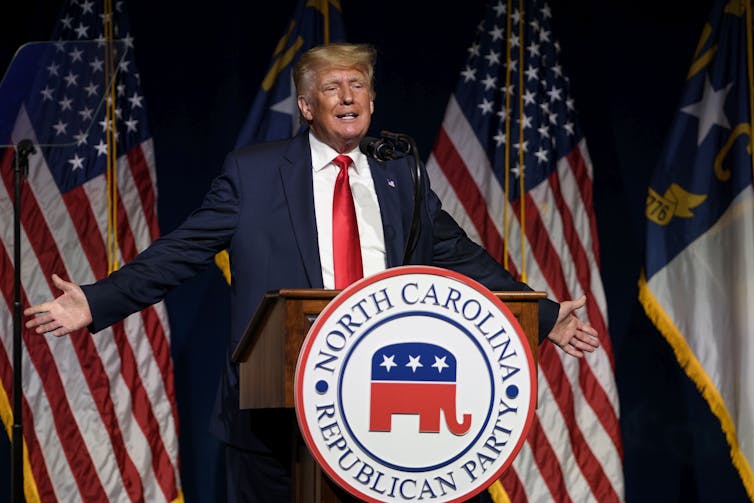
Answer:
[369,342,471,435]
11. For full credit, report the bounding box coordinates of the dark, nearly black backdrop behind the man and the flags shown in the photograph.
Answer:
[0,0,747,503]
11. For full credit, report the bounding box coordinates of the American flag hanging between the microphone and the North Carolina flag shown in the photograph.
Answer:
[427,0,624,503]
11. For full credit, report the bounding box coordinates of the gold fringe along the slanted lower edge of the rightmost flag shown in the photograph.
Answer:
[639,271,754,502]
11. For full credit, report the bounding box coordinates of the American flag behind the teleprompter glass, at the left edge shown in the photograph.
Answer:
[0,0,183,501]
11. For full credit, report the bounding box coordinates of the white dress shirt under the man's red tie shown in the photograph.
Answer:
[309,131,385,289]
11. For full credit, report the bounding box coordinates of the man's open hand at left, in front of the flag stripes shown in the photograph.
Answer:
[24,274,92,337]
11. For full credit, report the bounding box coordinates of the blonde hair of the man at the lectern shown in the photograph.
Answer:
[293,43,377,100]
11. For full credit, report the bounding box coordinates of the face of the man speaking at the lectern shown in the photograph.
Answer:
[298,66,374,153]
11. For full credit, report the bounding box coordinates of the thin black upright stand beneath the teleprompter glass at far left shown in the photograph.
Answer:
[11,140,36,503]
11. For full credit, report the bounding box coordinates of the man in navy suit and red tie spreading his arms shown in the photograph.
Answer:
[24,44,599,503]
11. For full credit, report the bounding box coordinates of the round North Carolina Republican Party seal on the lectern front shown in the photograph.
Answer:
[294,266,536,502]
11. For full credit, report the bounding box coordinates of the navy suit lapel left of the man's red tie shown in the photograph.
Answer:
[280,131,324,288]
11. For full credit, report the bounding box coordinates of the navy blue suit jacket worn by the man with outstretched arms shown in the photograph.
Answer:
[82,131,559,449]
